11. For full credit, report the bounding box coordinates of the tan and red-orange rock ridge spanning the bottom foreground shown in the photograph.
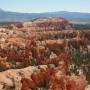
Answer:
[0,65,86,90]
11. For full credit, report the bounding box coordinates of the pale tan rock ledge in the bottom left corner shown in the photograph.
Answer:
[0,66,47,90]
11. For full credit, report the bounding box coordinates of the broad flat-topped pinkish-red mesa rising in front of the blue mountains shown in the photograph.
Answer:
[24,17,71,30]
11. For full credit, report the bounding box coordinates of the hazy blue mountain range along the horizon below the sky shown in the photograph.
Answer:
[0,9,90,24]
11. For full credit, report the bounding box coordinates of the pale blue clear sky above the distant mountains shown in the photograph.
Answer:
[0,0,90,13]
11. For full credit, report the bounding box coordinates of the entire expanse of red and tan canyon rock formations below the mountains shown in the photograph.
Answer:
[0,17,90,90]
